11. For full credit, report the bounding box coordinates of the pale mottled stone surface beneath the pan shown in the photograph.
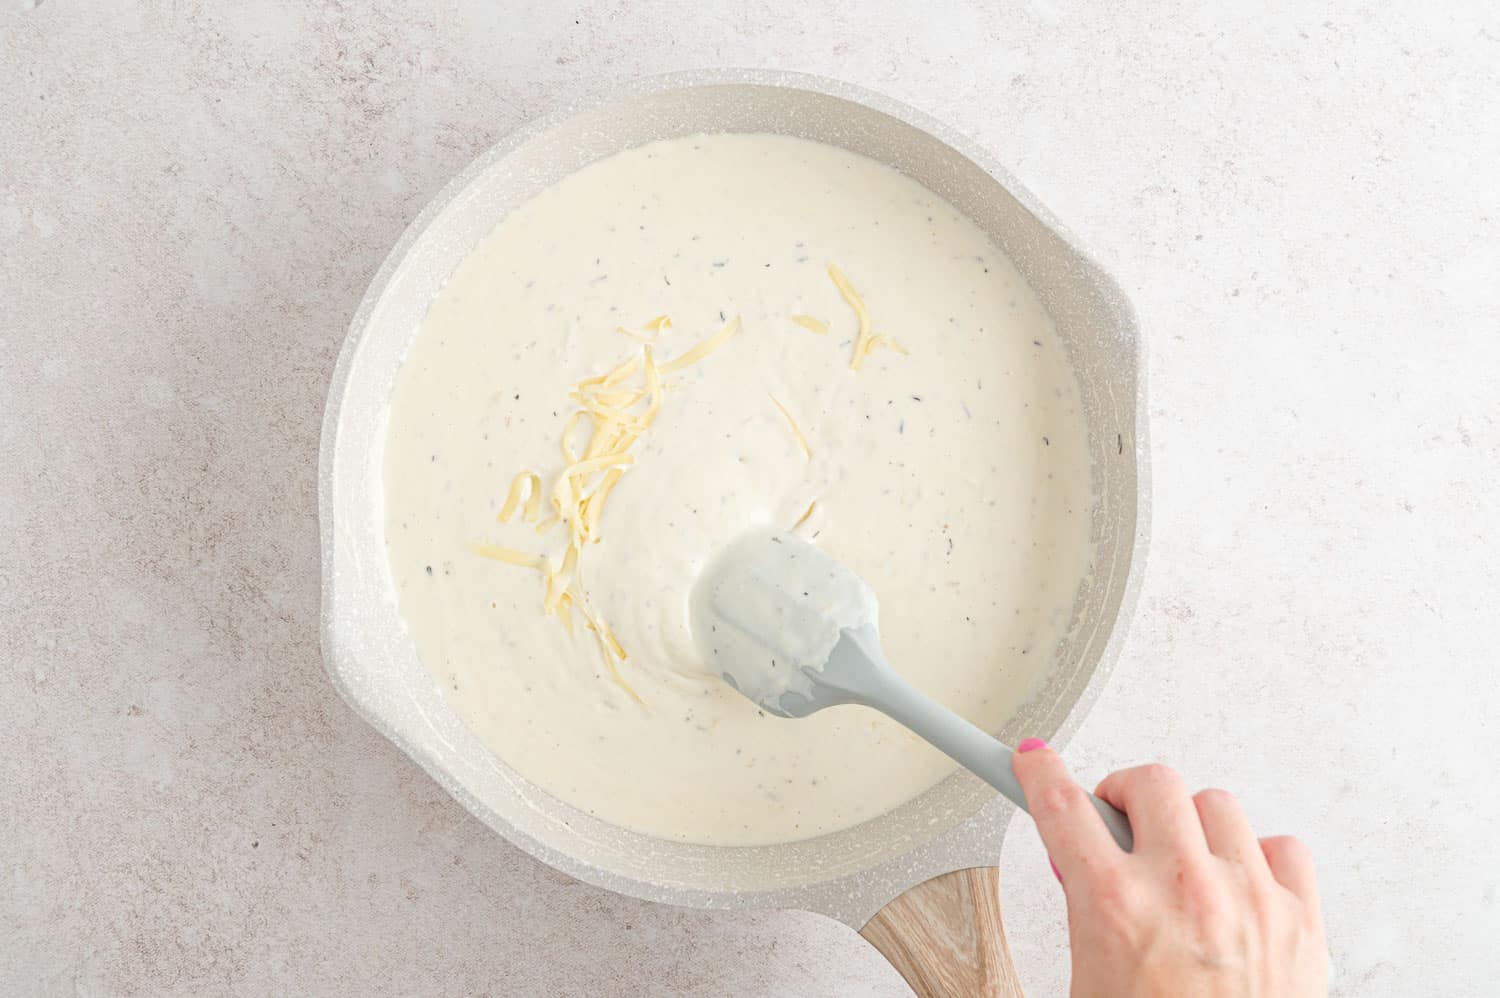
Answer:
[0,0,1500,996]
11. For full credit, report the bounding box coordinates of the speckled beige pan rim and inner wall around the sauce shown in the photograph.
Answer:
[318,71,1148,927]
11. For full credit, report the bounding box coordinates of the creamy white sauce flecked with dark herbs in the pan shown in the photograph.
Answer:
[386,135,1092,845]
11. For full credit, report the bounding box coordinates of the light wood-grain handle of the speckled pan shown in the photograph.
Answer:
[860,866,1023,998]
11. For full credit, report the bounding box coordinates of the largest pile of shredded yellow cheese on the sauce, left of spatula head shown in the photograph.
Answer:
[474,315,744,705]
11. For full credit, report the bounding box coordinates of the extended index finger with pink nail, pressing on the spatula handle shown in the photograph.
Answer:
[1011,738,1125,884]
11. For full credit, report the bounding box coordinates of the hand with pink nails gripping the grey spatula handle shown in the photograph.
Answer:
[1013,738,1328,998]
